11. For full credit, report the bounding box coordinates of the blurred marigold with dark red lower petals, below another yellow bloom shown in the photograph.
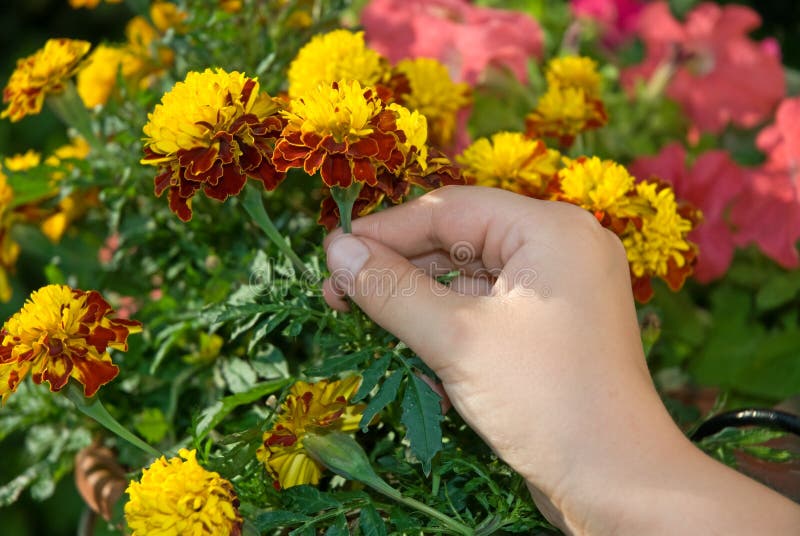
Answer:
[525,85,608,147]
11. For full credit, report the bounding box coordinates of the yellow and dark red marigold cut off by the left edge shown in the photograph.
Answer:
[0,285,142,401]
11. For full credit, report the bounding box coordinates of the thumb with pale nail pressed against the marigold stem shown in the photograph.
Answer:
[327,234,475,362]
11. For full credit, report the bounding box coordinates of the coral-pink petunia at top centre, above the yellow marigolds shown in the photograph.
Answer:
[361,0,543,84]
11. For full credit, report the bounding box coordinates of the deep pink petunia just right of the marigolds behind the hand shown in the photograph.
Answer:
[630,143,745,283]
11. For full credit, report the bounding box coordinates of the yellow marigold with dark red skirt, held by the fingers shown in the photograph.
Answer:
[272,80,406,188]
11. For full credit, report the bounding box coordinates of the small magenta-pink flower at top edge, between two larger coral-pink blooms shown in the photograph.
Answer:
[570,0,644,48]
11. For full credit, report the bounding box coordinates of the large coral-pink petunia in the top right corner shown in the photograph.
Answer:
[622,2,786,133]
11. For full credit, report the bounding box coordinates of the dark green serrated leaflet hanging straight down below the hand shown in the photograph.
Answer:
[400,375,442,475]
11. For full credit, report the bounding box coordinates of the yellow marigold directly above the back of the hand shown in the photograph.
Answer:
[456,132,560,197]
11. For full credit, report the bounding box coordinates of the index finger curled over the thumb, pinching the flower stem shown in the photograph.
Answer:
[325,186,542,269]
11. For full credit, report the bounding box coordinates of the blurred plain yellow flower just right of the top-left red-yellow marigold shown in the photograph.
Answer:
[77,45,141,108]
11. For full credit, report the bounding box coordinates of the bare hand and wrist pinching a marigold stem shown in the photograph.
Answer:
[324,186,796,534]
